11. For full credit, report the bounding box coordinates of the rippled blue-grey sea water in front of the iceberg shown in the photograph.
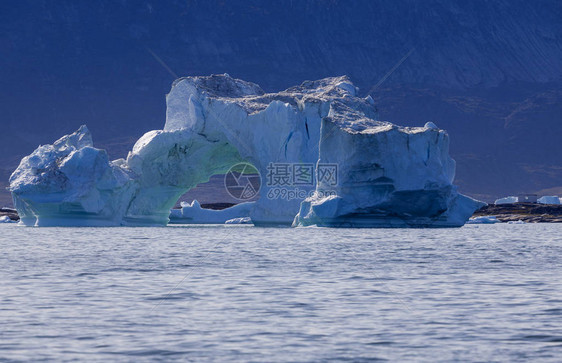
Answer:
[0,224,562,362]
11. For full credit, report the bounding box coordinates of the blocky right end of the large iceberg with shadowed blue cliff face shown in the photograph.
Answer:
[293,119,483,227]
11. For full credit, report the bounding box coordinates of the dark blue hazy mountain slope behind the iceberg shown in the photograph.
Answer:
[0,0,562,205]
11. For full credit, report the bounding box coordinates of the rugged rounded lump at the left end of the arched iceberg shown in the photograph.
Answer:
[10,126,137,226]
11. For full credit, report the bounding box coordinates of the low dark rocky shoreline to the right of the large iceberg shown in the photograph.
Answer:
[473,203,562,223]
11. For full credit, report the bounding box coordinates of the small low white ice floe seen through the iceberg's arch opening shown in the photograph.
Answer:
[170,200,254,224]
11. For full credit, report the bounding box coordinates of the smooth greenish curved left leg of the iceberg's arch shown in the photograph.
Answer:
[123,130,243,225]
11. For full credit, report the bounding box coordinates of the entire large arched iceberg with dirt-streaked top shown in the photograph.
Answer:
[10,74,483,227]
